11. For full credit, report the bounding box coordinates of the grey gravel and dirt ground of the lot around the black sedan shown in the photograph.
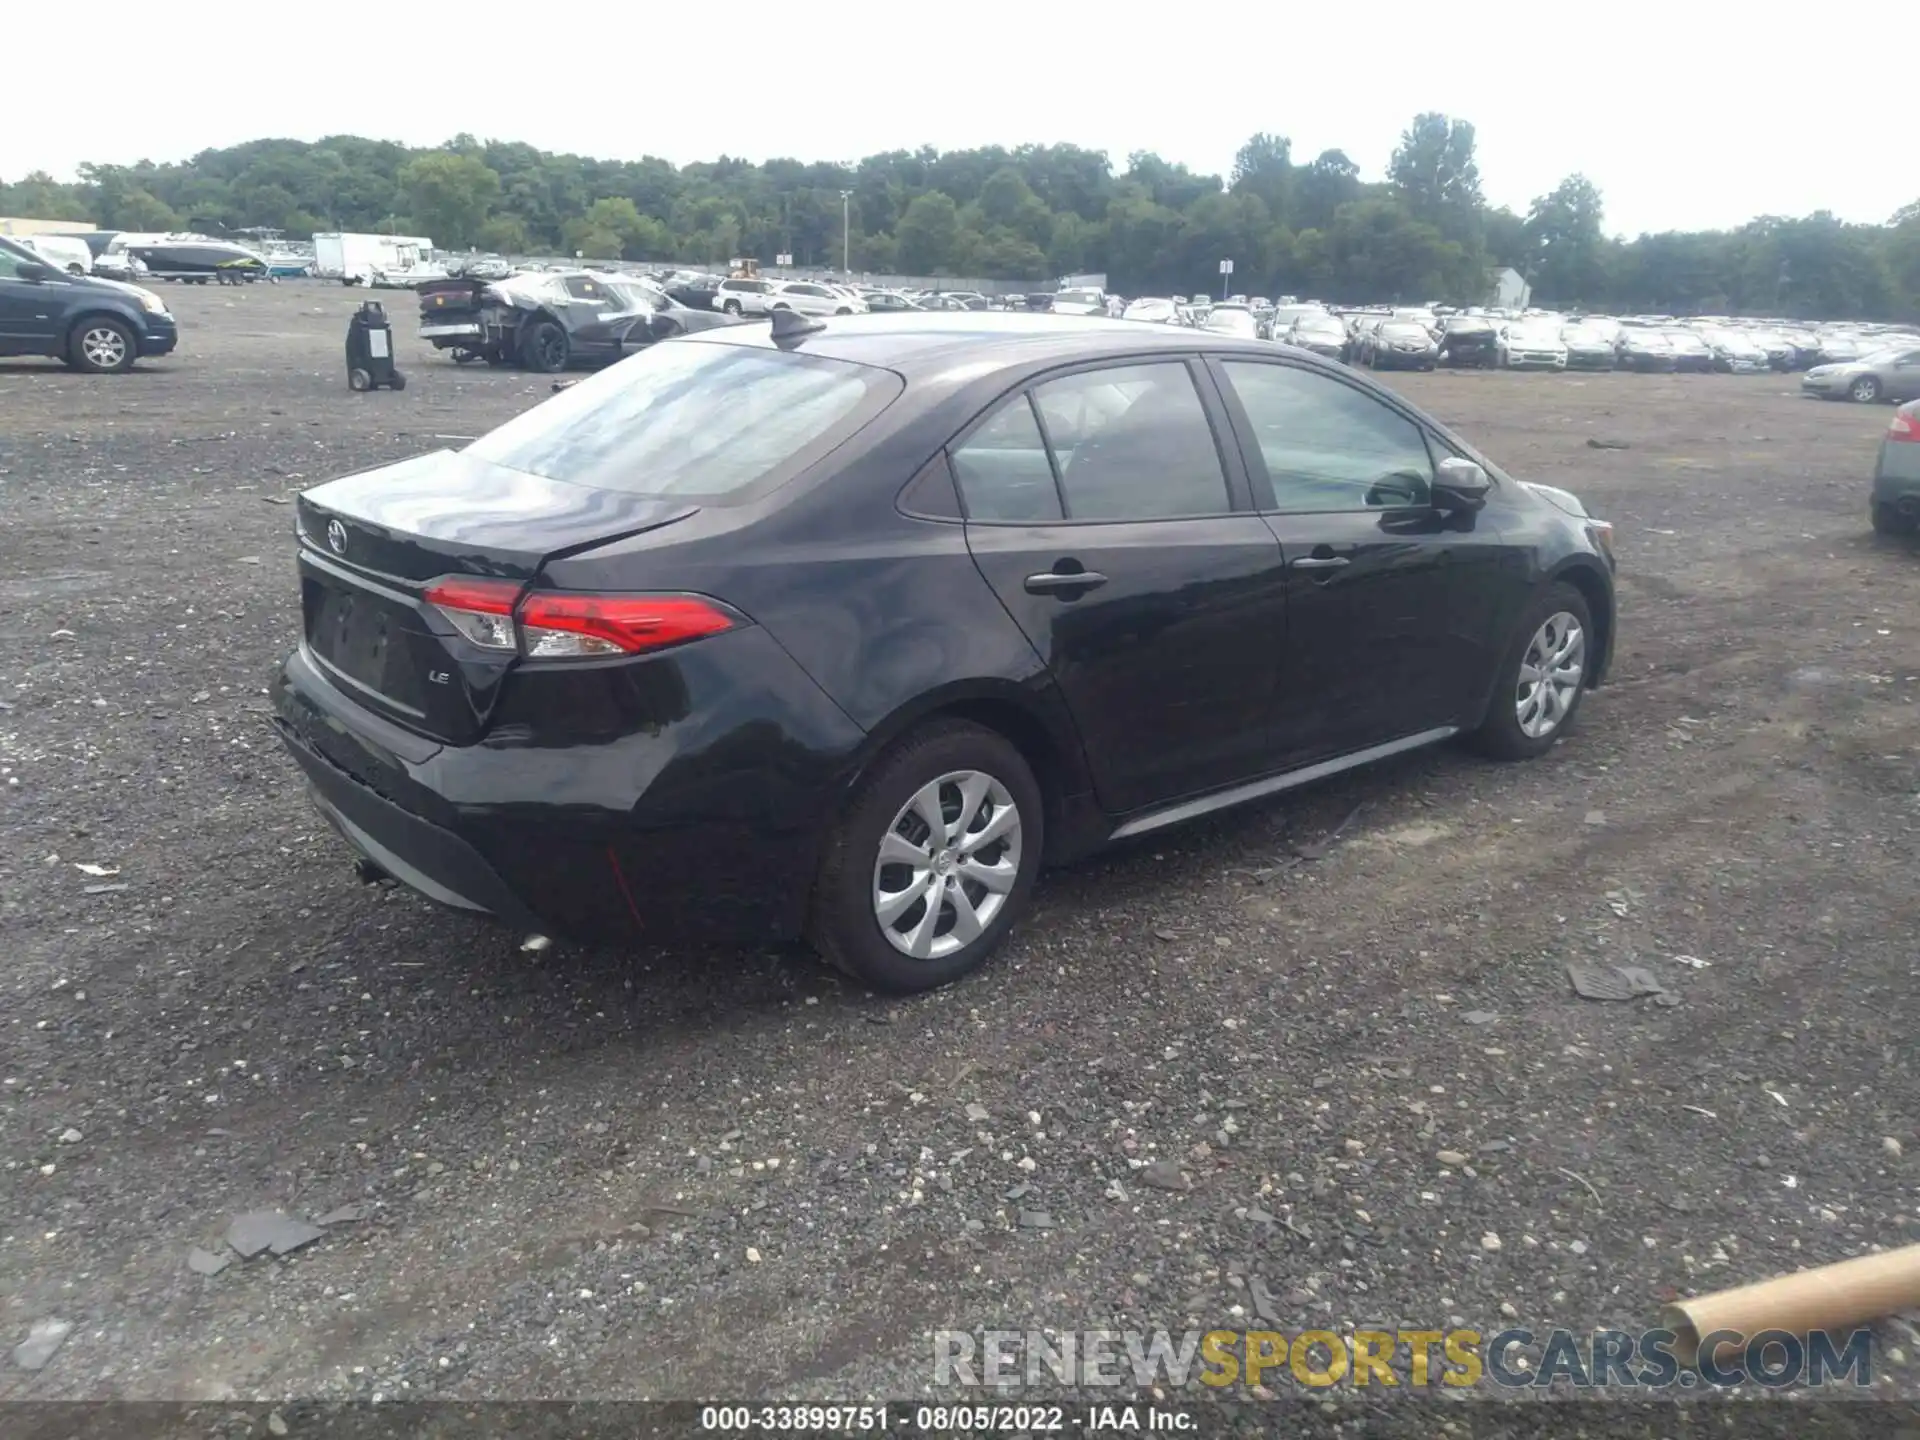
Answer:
[0,284,1920,1400]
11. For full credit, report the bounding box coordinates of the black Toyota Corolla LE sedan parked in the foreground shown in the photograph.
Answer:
[275,313,1615,991]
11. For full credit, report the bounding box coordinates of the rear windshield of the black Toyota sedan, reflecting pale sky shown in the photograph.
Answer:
[467,340,904,501]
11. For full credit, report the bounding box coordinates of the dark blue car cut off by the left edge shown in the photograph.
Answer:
[0,236,180,374]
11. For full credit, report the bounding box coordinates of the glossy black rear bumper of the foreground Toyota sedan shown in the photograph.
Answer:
[271,626,864,945]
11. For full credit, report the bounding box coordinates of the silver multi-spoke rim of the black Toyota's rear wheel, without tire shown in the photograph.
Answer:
[874,770,1023,960]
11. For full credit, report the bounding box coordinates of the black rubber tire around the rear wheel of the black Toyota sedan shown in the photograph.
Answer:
[806,720,1044,995]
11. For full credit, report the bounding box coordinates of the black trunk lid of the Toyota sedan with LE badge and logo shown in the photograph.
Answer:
[298,451,699,745]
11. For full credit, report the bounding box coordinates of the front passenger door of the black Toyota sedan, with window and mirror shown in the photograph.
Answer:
[1217,359,1503,766]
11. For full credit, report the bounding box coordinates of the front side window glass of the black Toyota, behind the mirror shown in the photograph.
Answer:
[1221,361,1432,515]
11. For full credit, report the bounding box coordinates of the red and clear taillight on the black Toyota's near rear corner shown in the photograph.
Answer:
[424,576,743,660]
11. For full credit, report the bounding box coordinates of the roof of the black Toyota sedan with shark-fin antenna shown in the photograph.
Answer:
[680,311,1275,382]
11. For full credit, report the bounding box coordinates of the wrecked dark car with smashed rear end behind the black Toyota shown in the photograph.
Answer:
[419,271,733,374]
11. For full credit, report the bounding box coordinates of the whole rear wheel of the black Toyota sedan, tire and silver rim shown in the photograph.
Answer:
[808,720,1044,995]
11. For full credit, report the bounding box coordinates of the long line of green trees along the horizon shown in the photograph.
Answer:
[0,113,1920,321]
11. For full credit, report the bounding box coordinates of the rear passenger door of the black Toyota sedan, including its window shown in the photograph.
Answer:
[952,359,1286,814]
